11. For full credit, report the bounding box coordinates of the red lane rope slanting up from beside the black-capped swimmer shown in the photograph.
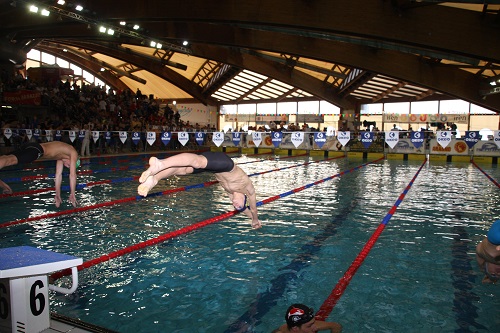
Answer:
[316,159,427,320]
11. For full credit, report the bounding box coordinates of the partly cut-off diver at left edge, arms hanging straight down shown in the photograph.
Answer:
[0,141,80,207]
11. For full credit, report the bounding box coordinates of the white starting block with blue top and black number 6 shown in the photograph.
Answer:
[0,246,83,333]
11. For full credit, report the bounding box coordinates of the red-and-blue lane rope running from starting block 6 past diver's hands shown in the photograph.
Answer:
[50,157,378,281]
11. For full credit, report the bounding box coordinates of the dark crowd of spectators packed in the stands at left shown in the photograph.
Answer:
[0,75,213,153]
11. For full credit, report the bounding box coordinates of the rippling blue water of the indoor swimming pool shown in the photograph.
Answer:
[0,155,500,333]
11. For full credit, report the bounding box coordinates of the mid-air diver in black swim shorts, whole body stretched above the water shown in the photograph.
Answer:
[137,152,262,229]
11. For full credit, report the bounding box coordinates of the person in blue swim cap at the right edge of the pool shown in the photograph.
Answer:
[476,220,500,283]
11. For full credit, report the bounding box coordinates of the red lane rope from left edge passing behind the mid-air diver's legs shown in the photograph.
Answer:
[0,156,343,228]
